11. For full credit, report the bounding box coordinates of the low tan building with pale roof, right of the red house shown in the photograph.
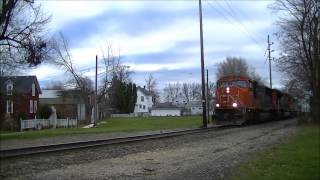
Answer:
[39,90,86,120]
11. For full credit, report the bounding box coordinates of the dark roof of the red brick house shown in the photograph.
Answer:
[0,76,42,94]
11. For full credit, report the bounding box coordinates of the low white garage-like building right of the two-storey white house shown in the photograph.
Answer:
[151,103,182,116]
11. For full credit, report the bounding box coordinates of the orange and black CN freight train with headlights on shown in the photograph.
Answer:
[214,76,295,125]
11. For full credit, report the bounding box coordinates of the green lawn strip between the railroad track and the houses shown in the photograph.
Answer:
[0,116,202,140]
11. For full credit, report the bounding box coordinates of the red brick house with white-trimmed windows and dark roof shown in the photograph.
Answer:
[0,76,41,119]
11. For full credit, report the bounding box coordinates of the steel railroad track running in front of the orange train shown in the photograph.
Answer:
[0,126,226,158]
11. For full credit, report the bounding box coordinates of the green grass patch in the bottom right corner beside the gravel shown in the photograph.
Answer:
[231,126,320,180]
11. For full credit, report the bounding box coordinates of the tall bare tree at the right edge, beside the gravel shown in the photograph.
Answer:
[272,0,320,121]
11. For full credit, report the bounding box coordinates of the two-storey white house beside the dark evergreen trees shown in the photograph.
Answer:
[134,87,153,113]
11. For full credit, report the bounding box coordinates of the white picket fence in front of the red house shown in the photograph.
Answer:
[20,118,78,131]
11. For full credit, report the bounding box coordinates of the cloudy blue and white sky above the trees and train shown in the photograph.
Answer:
[30,0,281,89]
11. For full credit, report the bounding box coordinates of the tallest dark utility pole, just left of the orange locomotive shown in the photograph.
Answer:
[199,0,208,128]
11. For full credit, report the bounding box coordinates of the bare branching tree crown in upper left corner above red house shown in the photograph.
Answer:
[0,0,50,75]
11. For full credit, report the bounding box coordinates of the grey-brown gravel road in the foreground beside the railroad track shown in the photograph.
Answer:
[0,119,298,180]
